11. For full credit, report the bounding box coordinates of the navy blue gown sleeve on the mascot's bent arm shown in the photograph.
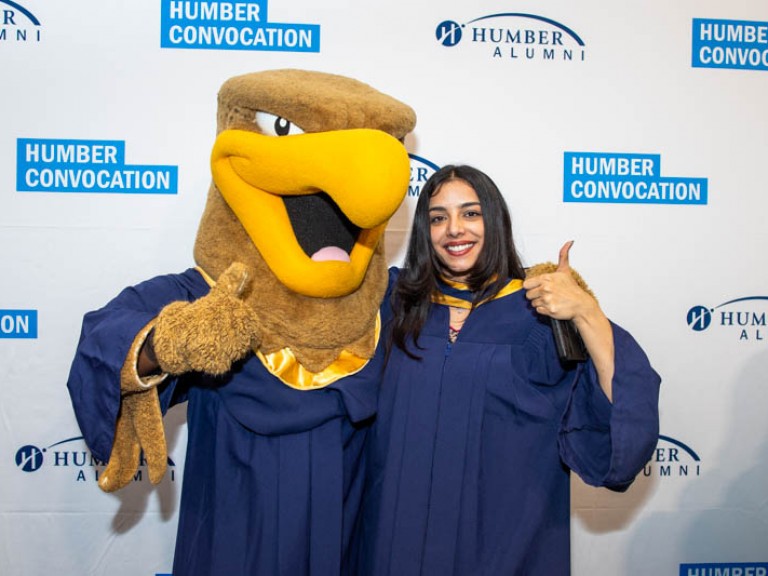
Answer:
[67,270,208,462]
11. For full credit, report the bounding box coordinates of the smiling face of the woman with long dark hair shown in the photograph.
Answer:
[429,180,485,281]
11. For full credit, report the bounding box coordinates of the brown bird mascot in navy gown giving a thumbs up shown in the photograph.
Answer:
[67,70,416,576]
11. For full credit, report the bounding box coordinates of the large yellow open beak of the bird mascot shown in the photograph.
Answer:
[211,129,410,298]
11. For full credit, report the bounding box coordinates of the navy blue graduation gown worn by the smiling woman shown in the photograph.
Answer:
[351,270,660,576]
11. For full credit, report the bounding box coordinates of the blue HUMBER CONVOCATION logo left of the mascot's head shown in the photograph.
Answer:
[16,138,178,194]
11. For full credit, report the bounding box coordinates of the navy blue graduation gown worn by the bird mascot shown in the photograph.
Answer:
[67,269,383,576]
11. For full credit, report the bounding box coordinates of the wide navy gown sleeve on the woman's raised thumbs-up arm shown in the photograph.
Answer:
[528,323,661,492]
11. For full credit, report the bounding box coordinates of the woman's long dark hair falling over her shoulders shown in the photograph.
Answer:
[390,165,525,358]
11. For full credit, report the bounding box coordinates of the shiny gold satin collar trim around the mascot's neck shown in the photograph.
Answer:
[195,266,381,390]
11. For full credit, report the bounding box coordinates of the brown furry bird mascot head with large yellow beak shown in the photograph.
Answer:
[195,69,416,366]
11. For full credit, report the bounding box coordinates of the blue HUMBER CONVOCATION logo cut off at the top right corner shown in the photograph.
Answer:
[691,18,768,70]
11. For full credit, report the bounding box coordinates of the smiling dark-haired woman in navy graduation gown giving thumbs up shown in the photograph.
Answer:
[353,166,659,576]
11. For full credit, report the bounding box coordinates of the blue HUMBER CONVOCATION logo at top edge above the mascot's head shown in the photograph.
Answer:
[160,0,320,52]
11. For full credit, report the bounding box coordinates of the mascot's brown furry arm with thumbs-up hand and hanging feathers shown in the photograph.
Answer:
[99,263,260,492]
